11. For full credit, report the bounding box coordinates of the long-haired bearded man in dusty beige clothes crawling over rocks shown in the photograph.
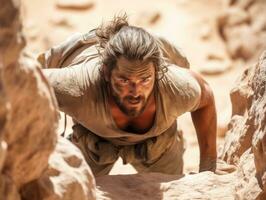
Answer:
[39,16,217,176]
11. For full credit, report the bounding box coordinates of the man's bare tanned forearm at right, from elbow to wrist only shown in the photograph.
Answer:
[191,101,217,172]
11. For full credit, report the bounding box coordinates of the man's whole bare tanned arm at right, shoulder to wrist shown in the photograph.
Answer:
[188,72,217,172]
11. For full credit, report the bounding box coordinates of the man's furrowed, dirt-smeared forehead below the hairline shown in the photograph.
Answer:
[114,57,155,76]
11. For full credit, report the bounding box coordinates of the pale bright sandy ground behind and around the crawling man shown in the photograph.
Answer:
[22,0,247,174]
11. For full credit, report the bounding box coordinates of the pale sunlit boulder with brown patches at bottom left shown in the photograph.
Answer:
[21,137,95,200]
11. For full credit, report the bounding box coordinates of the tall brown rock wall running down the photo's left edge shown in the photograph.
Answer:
[0,0,57,190]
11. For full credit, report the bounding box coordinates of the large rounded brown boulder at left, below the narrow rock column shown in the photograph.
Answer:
[3,52,58,188]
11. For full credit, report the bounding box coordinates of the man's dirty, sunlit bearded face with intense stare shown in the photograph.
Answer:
[110,57,155,117]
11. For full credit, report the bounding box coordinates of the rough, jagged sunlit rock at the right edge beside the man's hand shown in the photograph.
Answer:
[220,52,266,199]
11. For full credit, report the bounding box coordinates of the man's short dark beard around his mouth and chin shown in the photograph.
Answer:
[112,91,151,117]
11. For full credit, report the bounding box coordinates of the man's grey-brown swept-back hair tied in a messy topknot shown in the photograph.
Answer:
[96,14,167,78]
